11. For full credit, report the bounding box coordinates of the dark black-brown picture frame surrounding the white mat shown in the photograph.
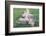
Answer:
[5,1,45,35]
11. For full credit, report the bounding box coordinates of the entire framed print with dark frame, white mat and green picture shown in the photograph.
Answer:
[5,1,45,35]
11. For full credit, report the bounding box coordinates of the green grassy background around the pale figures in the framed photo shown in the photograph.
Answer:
[13,8,39,28]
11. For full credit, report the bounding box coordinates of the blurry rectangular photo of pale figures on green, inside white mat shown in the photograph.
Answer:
[13,8,39,28]
